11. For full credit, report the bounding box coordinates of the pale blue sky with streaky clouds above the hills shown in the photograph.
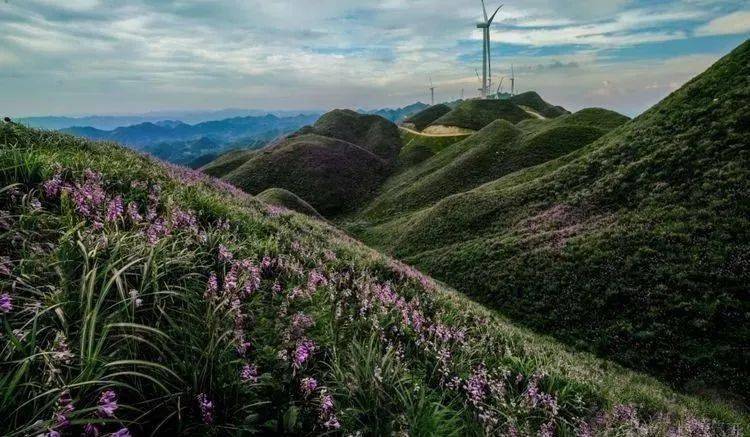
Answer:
[0,0,750,116]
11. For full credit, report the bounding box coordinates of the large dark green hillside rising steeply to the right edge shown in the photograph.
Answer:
[352,42,750,402]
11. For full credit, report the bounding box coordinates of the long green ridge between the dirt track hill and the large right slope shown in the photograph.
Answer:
[360,109,627,221]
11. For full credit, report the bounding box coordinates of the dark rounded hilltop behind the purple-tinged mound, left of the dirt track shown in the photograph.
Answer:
[312,109,401,161]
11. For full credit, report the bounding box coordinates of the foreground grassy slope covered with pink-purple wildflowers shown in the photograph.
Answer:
[0,124,750,436]
